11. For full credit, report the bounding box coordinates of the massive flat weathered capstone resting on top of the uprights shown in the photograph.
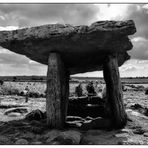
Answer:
[0,20,136,74]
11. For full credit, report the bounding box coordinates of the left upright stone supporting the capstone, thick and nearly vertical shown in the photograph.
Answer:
[46,53,69,128]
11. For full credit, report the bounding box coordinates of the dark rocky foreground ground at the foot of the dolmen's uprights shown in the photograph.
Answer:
[0,109,148,145]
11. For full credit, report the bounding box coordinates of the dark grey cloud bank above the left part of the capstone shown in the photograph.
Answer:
[0,4,98,27]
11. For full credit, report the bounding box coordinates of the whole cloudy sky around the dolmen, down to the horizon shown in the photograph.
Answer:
[0,4,148,77]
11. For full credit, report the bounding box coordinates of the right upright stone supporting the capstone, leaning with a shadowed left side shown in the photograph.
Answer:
[103,54,127,128]
